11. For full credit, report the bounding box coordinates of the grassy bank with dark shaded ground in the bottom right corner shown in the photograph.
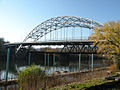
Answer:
[50,78,120,90]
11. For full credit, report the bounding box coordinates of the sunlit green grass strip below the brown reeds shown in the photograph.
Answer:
[50,78,113,90]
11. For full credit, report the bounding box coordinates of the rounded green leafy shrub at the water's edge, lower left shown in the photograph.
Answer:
[18,65,46,90]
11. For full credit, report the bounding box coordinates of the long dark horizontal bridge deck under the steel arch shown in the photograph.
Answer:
[4,40,94,47]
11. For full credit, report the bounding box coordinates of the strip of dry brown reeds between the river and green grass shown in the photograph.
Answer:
[0,68,108,90]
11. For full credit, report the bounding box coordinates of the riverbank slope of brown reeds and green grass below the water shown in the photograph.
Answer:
[0,68,120,90]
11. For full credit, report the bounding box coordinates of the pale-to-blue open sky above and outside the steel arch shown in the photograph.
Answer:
[0,0,120,42]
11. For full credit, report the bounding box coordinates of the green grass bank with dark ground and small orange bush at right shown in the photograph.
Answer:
[50,65,120,90]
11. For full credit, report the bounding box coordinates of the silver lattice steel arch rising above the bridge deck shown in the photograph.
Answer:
[23,16,103,42]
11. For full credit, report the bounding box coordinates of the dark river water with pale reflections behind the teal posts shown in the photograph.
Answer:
[0,55,109,80]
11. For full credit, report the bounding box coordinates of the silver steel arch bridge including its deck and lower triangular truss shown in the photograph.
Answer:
[16,16,103,52]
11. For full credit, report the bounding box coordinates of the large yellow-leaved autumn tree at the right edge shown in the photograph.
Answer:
[90,21,120,69]
